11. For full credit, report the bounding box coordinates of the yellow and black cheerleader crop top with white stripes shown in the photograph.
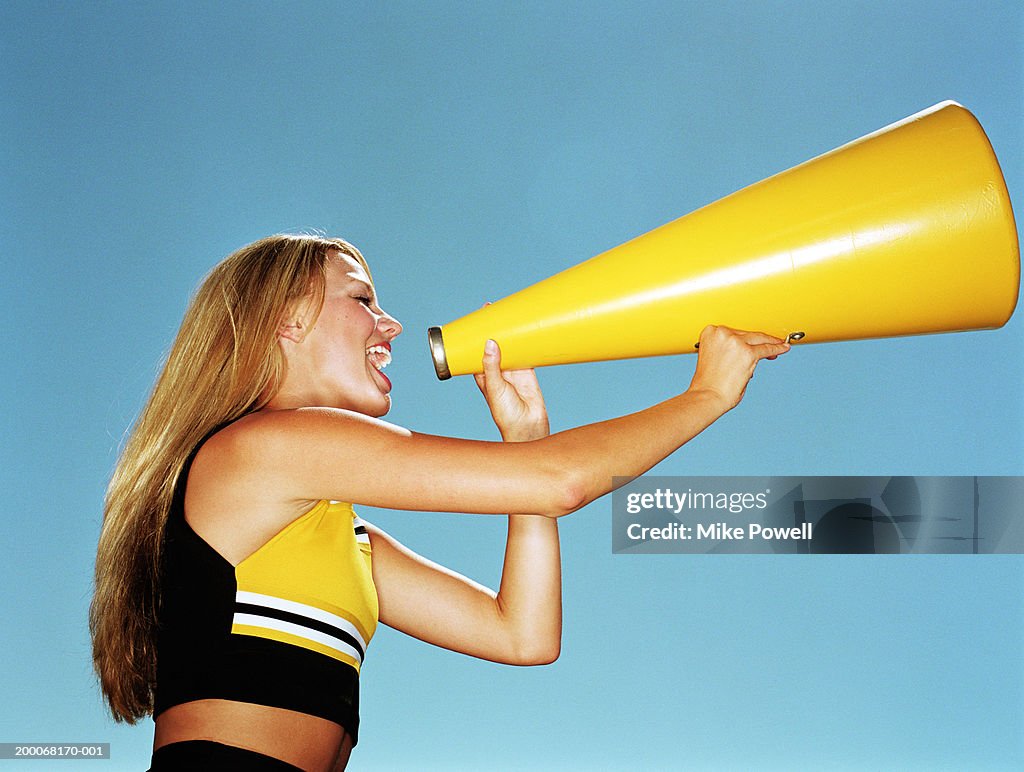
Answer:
[153,442,378,744]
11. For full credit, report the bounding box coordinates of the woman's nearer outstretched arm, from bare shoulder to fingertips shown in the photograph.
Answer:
[204,327,788,515]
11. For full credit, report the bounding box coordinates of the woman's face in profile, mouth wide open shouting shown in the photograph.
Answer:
[282,252,401,416]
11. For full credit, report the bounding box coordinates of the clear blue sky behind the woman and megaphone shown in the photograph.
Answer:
[0,0,1024,770]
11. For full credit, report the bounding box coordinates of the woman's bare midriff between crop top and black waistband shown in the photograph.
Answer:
[153,699,352,772]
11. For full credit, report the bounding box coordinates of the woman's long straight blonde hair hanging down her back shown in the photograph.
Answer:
[89,235,369,724]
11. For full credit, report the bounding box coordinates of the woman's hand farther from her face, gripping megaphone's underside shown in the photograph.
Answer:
[689,325,790,411]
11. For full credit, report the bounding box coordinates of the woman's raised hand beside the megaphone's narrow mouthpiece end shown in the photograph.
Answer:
[473,341,551,442]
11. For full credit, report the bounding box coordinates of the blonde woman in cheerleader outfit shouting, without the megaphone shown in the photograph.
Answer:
[90,235,788,772]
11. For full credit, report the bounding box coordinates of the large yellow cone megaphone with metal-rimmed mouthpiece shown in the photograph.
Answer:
[429,101,1020,380]
